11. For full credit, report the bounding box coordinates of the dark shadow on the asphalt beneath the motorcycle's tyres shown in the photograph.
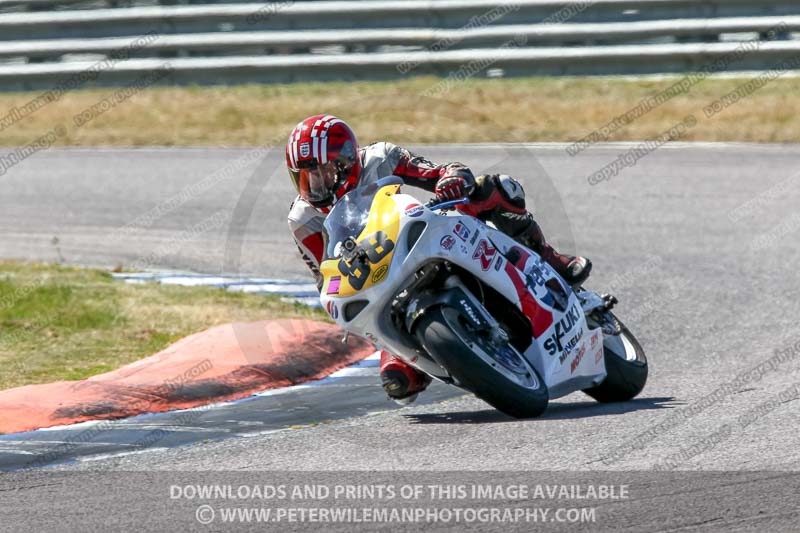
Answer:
[403,396,679,424]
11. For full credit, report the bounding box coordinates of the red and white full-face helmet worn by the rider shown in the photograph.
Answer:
[286,115,361,208]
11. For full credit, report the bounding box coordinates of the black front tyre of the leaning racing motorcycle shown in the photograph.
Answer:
[414,306,549,418]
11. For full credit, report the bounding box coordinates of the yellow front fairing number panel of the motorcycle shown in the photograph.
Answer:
[320,185,400,297]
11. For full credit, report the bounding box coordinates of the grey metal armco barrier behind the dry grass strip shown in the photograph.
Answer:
[0,0,800,90]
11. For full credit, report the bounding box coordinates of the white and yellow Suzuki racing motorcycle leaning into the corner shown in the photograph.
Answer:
[320,176,647,418]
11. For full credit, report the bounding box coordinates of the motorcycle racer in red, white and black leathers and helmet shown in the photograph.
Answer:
[286,115,592,403]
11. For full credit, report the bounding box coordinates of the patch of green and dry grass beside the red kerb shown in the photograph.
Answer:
[0,261,327,390]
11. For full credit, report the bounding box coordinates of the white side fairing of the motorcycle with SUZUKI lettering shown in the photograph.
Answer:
[320,189,606,398]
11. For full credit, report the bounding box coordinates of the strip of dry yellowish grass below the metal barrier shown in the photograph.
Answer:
[0,77,800,147]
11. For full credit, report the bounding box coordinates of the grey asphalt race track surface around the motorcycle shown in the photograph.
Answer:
[0,144,800,531]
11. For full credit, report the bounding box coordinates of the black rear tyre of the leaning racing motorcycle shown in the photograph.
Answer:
[583,311,647,403]
